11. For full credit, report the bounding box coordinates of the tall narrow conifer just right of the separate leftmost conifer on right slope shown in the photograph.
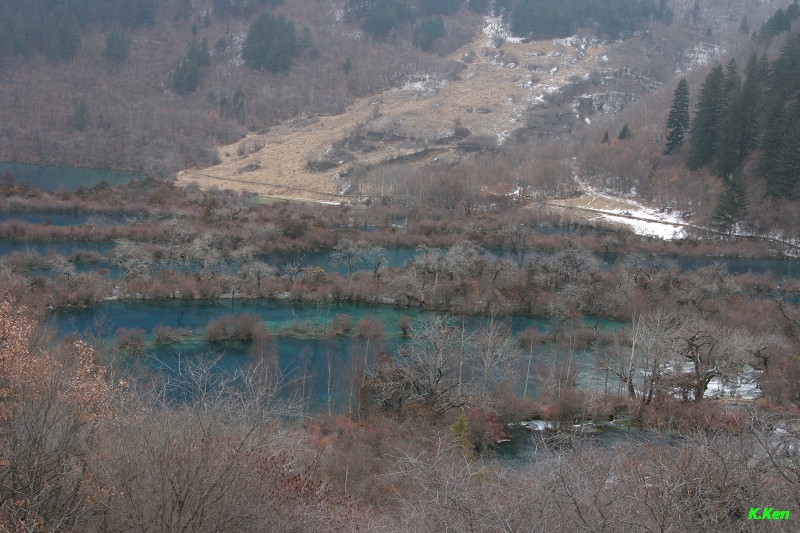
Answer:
[687,65,725,170]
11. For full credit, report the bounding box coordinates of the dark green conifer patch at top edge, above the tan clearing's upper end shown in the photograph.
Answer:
[509,0,672,39]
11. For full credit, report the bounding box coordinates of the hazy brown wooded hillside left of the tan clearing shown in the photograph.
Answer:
[0,0,478,177]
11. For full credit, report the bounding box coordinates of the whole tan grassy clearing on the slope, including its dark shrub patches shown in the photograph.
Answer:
[178,26,636,199]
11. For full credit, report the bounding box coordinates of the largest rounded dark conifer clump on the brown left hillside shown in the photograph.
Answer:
[242,13,297,72]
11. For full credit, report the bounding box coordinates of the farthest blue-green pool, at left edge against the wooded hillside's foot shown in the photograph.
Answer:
[0,163,138,191]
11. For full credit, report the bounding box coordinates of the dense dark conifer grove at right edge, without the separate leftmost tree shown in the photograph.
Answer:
[676,24,800,228]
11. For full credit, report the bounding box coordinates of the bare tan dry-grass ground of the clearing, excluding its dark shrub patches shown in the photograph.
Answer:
[178,26,614,200]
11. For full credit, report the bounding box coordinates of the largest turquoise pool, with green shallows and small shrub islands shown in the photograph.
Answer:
[50,300,600,407]
